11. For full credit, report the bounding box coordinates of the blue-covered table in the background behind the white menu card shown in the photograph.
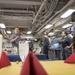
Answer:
[7,54,47,62]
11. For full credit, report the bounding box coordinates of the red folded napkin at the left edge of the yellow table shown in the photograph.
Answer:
[0,52,11,68]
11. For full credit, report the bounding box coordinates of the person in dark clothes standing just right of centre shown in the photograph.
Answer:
[43,34,49,59]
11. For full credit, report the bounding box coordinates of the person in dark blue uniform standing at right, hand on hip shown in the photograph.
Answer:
[61,32,71,60]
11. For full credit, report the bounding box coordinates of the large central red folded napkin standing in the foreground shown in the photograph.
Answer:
[20,52,48,75]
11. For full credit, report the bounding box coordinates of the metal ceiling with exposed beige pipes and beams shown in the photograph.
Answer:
[0,0,75,36]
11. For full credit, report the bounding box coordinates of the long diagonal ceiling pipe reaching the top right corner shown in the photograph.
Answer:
[37,0,75,32]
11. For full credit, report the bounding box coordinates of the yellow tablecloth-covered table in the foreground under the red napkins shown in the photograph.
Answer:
[0,61,75,75]
